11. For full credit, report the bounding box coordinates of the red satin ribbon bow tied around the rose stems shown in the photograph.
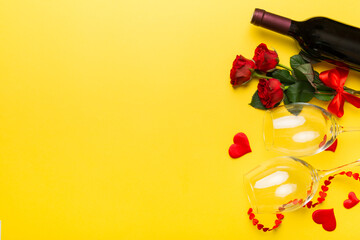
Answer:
[319,68,360,117]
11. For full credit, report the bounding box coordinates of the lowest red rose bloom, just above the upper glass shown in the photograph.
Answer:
[258,78,284,108]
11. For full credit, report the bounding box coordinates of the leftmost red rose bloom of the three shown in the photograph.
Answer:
[230,55,255,86]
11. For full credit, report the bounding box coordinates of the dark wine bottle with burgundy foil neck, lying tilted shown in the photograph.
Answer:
[251,8,360,71]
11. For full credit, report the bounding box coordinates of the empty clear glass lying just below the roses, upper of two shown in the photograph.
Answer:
[264,103,360,157]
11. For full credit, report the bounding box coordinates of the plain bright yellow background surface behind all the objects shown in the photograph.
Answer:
[0,0,360,240]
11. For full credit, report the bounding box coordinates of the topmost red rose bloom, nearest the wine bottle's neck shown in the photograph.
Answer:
[253,43,279,72]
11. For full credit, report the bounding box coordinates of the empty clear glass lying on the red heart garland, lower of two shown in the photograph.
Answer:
[244,157,360,213]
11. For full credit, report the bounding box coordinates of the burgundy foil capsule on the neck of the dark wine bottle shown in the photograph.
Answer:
[251,8,293,36]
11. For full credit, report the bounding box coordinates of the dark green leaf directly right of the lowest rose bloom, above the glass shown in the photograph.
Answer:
[285,81,315,103]
